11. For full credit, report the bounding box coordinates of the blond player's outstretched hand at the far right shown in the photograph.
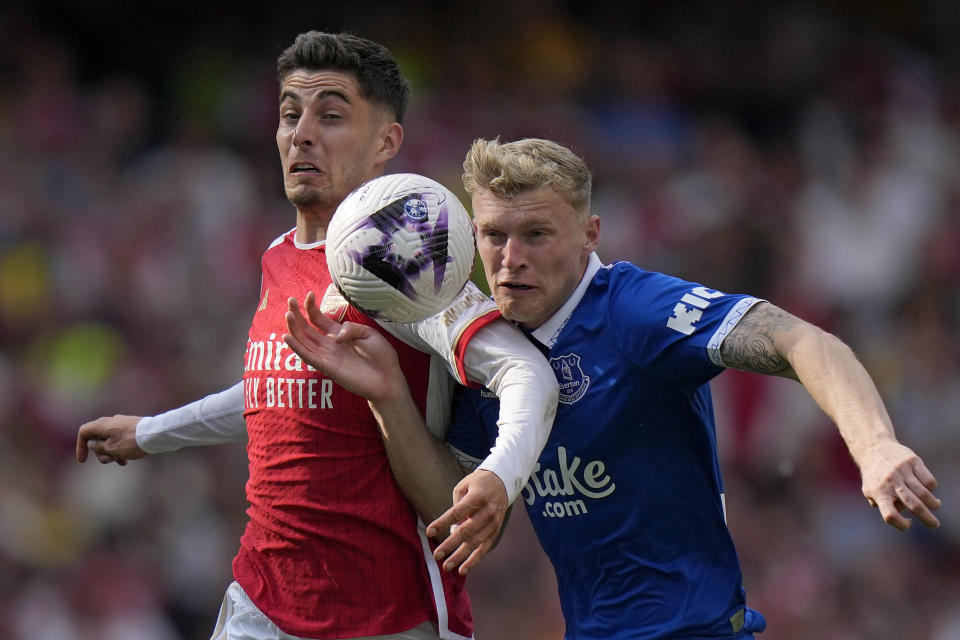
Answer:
[858,440,940,531]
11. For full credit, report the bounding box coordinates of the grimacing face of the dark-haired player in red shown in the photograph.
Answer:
[277,69,399,221]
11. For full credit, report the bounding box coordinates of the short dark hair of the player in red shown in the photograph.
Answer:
[277,31,410,123]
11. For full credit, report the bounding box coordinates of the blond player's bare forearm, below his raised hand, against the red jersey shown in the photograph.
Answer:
[370,391,466,522]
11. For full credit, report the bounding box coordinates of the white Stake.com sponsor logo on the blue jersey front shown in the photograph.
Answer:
[523,447,617,518]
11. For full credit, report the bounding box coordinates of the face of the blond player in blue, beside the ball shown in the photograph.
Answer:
[472,187,600,329]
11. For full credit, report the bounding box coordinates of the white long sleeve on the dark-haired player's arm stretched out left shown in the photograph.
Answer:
[136,382,247,454]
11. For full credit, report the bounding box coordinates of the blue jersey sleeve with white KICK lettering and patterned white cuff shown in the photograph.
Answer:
[607,271,760,386]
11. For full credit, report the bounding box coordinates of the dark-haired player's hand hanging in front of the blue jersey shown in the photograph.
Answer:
[427,469,508,575]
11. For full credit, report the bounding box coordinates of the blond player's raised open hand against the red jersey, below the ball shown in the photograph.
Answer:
[283,291,407,401]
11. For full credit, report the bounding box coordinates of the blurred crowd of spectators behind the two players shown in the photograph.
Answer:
[0,0,960,640]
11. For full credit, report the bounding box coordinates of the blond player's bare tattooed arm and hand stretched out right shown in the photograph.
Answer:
[720,302,940,530]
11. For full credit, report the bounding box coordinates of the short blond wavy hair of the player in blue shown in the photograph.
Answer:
[463,138,592,215]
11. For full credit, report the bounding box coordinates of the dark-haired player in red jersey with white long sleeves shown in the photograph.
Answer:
[77,32,557,640]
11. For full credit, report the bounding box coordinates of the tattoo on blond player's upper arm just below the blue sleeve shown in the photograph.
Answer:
[720,302,800,378]
